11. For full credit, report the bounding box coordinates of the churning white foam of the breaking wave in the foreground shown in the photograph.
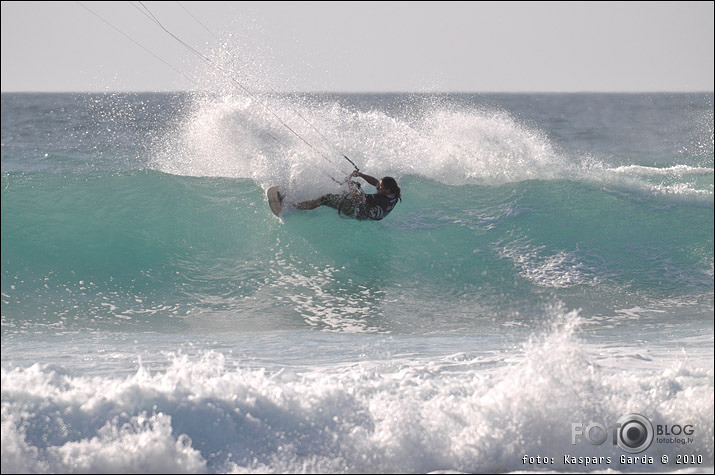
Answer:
[2,308,713,473]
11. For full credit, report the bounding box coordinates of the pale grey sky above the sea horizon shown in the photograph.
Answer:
[0,1,715,92]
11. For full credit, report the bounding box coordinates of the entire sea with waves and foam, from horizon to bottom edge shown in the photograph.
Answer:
[0,93,715,473]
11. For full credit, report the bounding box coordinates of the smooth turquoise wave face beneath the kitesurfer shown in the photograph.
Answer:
[2,170,713,333]
